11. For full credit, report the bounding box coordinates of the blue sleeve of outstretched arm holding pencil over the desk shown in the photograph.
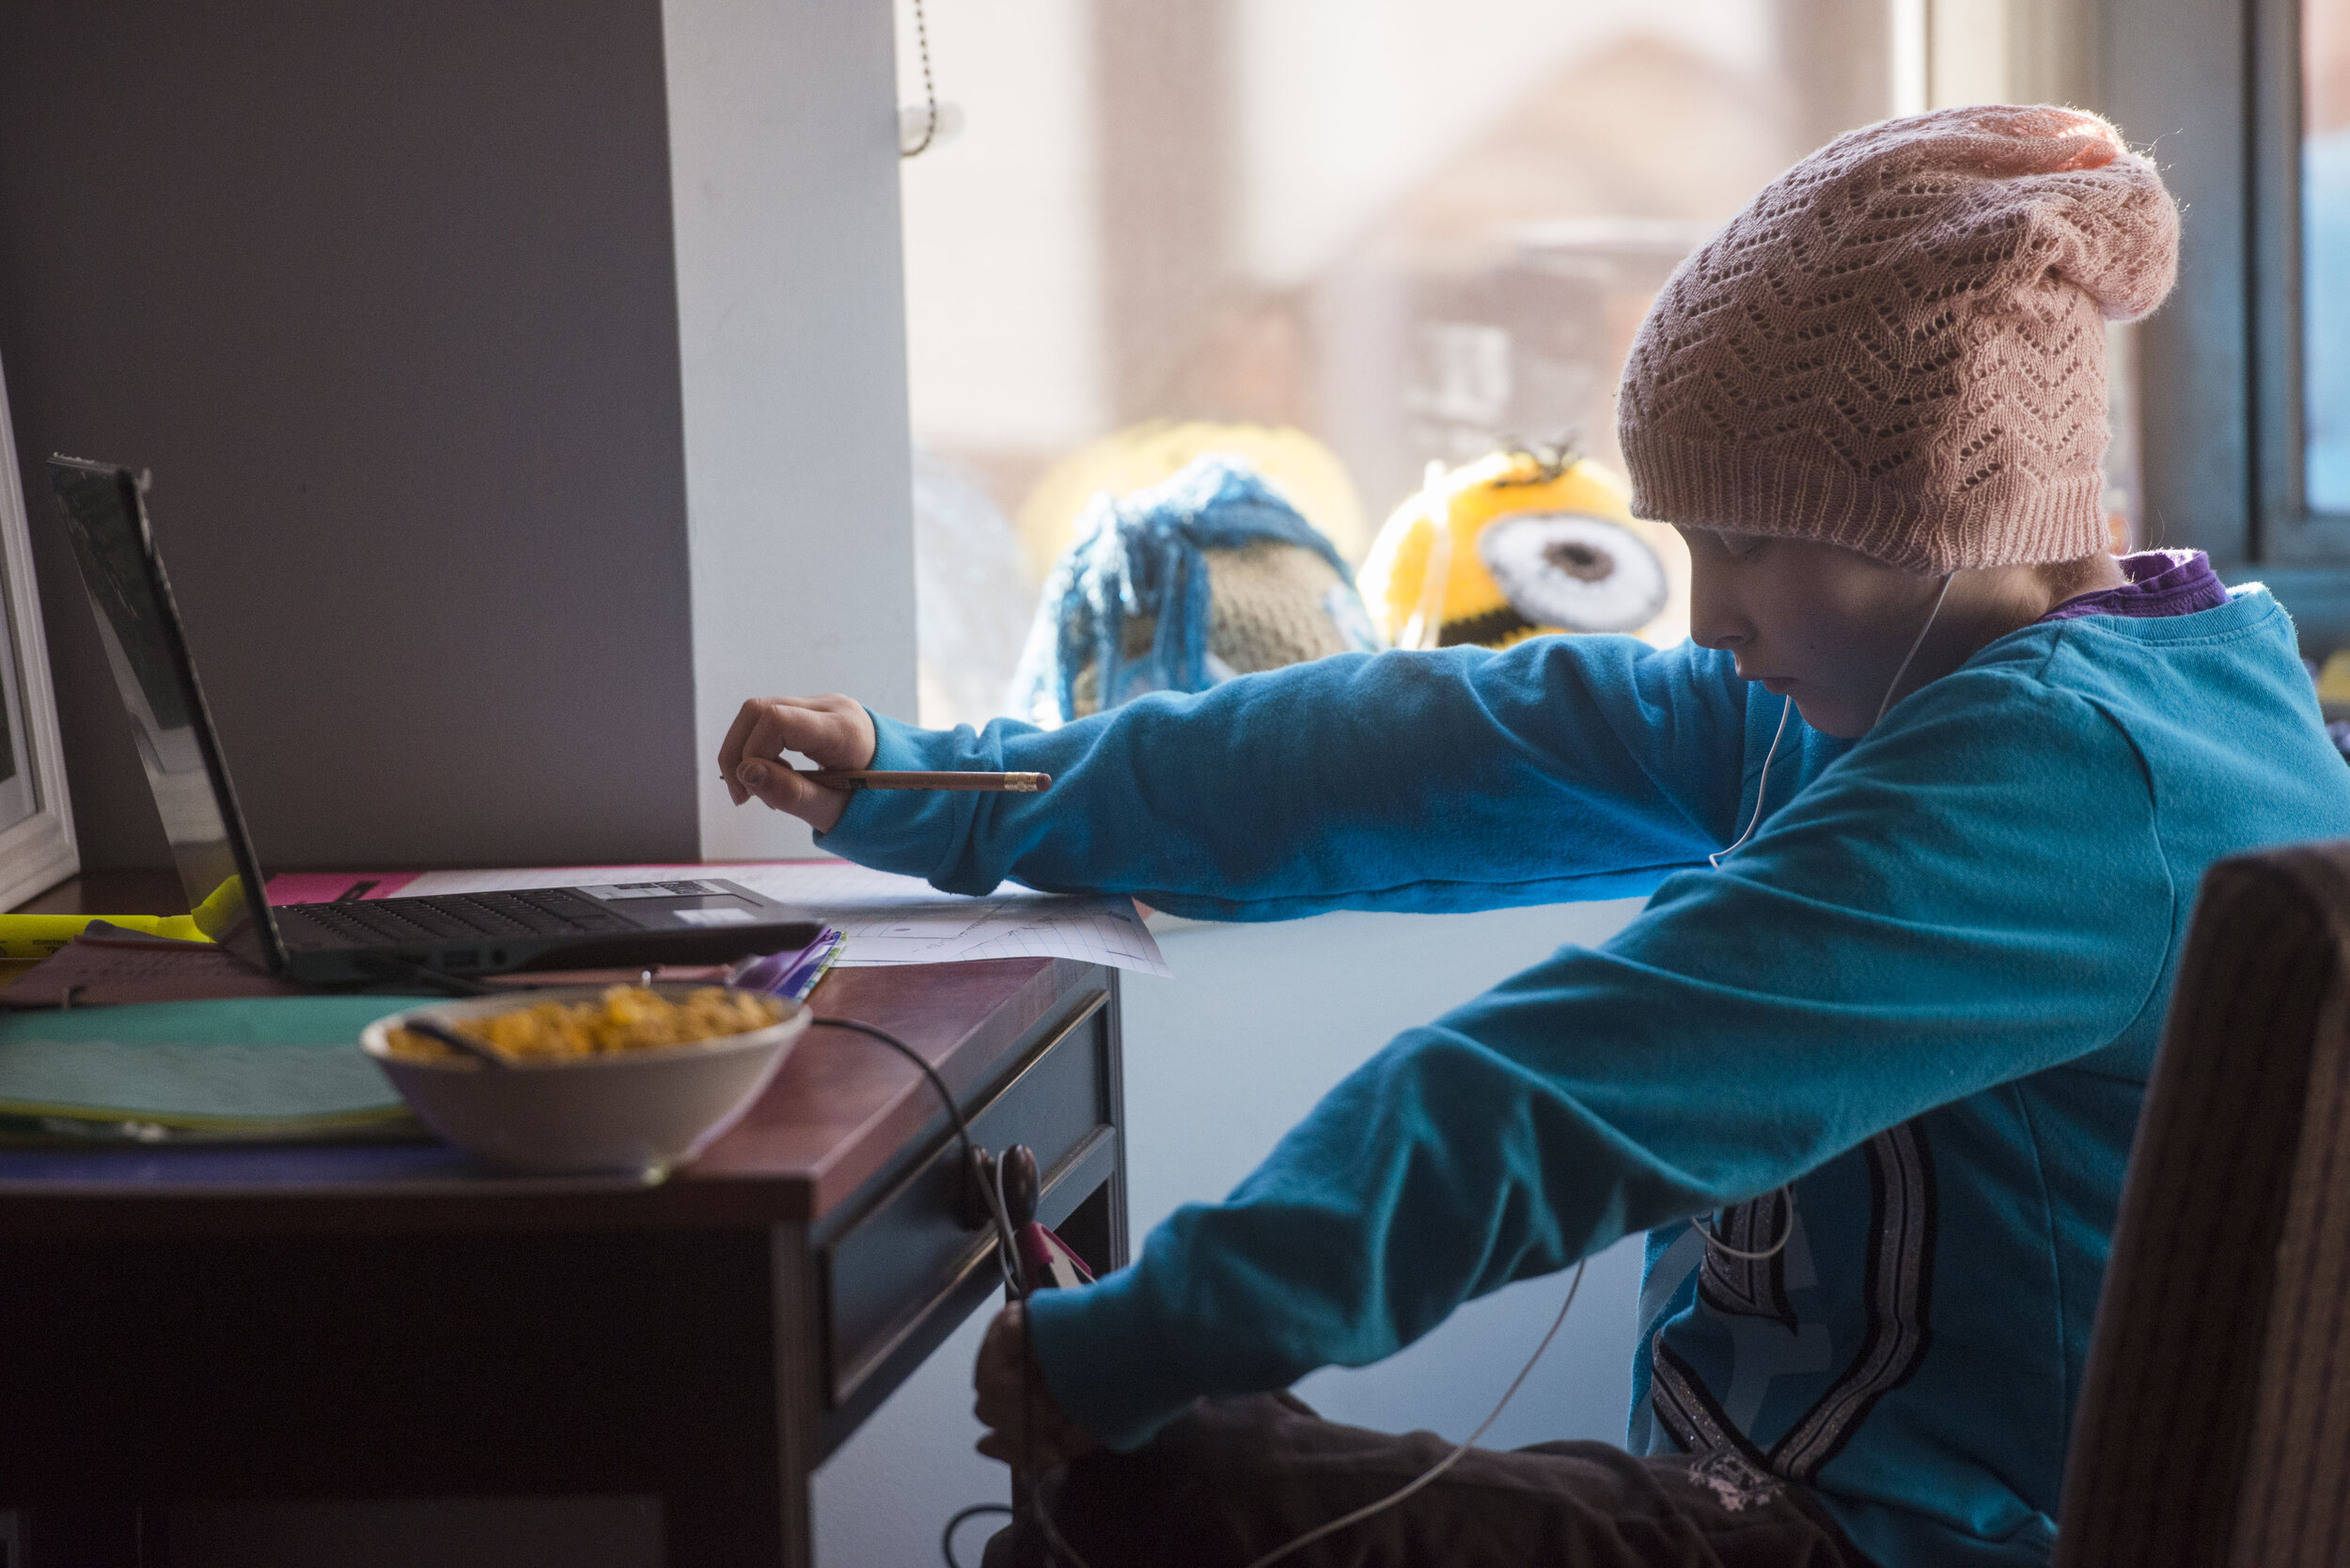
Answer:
[821,637,1805,919]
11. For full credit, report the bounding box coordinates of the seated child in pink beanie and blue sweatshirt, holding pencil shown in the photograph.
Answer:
[719,108,2350,1568]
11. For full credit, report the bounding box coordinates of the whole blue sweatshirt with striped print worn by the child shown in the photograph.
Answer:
[825,590,2350,1568]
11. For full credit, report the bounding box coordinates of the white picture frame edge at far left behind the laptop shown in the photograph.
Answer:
[0,348,83,910]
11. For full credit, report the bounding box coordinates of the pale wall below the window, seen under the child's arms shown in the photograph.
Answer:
[816,901,1640,1568]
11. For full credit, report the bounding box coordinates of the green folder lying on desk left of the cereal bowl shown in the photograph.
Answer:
[0,996,432,1142]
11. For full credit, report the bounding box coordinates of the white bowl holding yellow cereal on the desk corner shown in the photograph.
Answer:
[360,980,808,1175]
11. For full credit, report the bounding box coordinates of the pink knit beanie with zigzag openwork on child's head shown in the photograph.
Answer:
[1617,106,2179,572]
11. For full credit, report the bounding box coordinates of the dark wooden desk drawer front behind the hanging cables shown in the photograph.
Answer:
[821,992,1117,1405]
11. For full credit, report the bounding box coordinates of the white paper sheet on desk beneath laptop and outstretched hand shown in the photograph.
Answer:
[381,860,1168,976]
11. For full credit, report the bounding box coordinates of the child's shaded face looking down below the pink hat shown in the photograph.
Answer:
[1681,529,1958,738]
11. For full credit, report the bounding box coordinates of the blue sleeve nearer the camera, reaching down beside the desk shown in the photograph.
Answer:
[1034,672,2162,1448]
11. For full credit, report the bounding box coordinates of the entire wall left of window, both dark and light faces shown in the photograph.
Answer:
[0,0,915,868]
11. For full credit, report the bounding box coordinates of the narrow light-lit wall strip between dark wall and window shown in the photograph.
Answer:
[661,0,915,860]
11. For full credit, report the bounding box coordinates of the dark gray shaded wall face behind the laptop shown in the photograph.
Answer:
[0,0,696,865]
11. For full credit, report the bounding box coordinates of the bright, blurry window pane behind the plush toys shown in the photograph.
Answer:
[901,0,1922,724]
